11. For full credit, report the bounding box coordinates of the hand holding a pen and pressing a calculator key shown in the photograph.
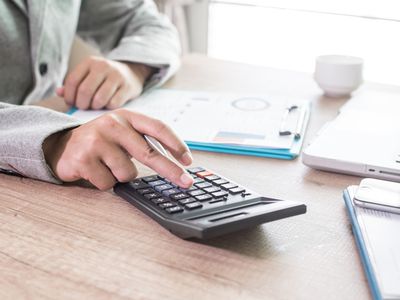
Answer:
[43,109,193,190]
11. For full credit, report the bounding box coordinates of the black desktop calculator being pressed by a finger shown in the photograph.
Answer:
[114,167,306,239]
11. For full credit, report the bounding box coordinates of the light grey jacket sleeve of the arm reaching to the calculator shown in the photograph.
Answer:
[0,103,80,183]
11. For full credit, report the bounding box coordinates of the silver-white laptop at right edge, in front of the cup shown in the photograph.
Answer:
[302,91,400,181]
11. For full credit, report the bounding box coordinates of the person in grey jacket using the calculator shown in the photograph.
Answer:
[0,0,193,190]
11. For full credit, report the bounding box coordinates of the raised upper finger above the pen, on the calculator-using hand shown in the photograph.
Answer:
[121,110,193,166]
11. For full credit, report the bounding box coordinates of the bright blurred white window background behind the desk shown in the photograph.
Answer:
[156,0,400,85]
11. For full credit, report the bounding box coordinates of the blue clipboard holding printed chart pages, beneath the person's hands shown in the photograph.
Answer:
[68,89,310,160]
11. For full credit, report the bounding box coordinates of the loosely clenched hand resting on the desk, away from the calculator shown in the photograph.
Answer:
[57,56,154,109]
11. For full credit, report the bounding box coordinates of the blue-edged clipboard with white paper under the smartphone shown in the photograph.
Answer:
[343,186,400,300]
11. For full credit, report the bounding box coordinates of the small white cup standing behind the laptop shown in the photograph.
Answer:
[314,55,363,97]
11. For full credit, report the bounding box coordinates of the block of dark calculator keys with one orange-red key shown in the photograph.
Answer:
[126,167,252,214]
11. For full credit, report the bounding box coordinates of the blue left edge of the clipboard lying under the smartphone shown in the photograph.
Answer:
[343,186,382,300]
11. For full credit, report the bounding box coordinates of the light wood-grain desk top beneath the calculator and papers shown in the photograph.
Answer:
[0,55,391,299]
